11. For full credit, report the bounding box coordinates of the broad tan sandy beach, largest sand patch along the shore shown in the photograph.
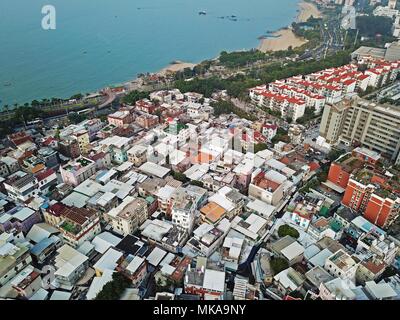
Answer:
[258,29,307,52]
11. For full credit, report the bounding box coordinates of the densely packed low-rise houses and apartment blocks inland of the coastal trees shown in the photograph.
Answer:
[0,0,400,301]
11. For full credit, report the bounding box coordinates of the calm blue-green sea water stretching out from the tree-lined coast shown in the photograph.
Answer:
[0,0,298,108]
